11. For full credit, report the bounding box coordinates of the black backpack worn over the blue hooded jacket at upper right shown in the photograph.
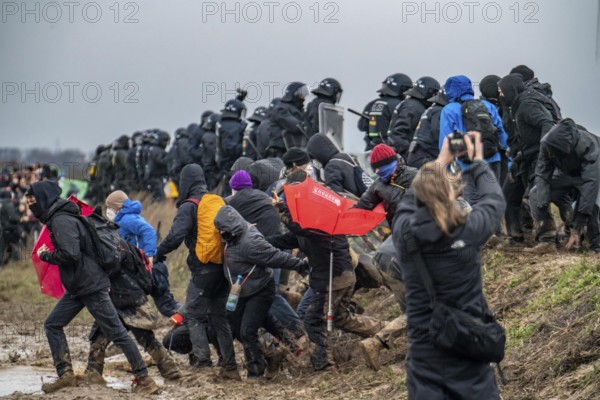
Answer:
[460,99,500,158]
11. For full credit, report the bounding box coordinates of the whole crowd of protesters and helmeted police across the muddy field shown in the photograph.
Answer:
[19,65,600,399]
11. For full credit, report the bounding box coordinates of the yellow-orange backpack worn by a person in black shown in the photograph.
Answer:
[185,193,225,264]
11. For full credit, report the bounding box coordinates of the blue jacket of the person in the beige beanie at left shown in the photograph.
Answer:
[115,199,156,257]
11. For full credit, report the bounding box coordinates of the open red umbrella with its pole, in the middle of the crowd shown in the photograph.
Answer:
[283,178,385,332]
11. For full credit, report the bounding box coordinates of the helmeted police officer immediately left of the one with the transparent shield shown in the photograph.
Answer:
[272,82,311,149]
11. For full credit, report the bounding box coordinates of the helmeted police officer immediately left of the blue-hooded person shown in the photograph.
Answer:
[406,90,448,168]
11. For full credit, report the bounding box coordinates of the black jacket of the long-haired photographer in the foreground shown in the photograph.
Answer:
[393,162,506,344]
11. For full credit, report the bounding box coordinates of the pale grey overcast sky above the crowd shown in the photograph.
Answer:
[0,0,600,152]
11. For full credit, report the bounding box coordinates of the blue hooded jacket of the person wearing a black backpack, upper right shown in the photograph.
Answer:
[439,75,508,170]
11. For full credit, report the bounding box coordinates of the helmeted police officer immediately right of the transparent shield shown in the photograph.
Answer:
[358,74,412,151]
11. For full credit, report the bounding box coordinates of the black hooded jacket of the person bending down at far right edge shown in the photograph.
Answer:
[535,118,600,229]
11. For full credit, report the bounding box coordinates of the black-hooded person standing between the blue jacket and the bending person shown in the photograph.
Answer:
[498,74,570,242]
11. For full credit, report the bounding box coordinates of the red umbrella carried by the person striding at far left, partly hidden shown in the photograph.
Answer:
[31,196,94,299]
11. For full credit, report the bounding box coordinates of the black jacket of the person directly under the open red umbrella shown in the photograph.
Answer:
[267,204,354,292]
